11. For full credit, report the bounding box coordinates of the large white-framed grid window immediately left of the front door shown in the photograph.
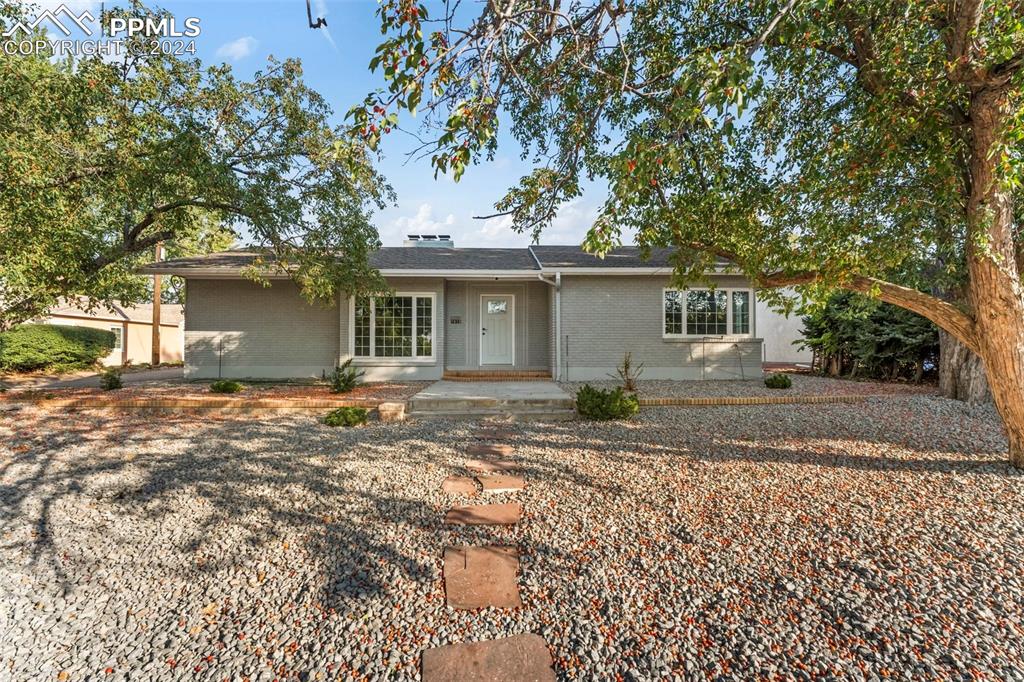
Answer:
[352,293,434,359]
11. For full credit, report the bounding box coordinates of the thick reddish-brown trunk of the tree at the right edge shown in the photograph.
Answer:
[967,88,1024,469]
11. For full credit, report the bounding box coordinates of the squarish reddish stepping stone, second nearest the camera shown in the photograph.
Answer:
[444,547,522,609]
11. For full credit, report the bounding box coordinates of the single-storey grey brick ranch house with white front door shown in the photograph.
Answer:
[143,236,802,381]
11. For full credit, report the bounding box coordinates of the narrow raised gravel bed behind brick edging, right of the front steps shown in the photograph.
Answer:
[560,374,938,398]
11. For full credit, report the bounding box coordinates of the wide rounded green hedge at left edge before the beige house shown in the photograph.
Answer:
[0,325,114,372]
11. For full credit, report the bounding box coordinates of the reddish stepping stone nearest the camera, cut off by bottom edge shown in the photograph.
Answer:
[420,634,555,682]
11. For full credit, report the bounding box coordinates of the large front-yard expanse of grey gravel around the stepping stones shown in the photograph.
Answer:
[0,395,1024,681]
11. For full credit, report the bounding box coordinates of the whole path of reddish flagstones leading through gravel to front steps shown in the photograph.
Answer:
[421,421,555,682]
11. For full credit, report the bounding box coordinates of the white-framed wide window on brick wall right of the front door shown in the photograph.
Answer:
[662,289,754,338]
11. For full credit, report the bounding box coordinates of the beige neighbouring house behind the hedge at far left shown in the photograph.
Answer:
[40,300,184,367]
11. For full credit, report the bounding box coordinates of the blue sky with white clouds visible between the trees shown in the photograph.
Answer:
[37,0,603,246]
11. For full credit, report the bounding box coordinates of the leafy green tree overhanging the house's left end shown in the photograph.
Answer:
[0,3,390,330]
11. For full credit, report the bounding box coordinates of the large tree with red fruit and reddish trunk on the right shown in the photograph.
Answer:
[352,0,1024,467]
